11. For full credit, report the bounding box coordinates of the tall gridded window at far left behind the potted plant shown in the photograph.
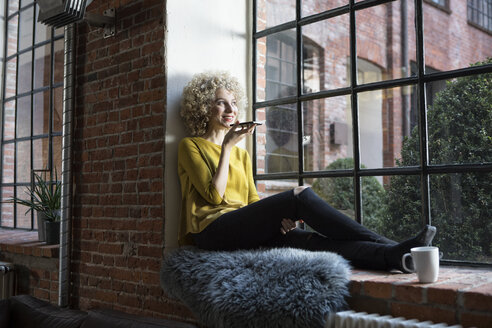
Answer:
[0,0,64,229]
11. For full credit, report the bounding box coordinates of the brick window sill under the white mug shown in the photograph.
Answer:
[348,267,492,327]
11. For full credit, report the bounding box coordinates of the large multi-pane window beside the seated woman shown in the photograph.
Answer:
[253,0,492,265]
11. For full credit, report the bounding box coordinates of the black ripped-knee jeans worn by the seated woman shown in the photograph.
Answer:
[193,188,396,270]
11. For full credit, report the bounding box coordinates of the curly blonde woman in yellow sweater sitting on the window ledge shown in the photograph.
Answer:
[178,72,436,271]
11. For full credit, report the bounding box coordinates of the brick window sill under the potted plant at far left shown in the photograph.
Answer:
[0,228,60,258]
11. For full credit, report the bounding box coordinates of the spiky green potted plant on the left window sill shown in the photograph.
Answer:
[6,170,61,245]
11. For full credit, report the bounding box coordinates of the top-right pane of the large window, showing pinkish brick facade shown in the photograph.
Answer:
[423,1,492,71]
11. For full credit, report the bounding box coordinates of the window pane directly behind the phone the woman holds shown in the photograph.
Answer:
[256,104,299,173]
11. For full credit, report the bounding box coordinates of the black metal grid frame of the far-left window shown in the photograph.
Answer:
[0,1,64,230]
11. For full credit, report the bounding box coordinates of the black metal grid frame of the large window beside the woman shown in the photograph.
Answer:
[252,0,492,266]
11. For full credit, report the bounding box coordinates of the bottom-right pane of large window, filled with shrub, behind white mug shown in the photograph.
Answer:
[430,173,492,263]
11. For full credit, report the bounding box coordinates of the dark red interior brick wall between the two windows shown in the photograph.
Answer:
[71,0,194,318]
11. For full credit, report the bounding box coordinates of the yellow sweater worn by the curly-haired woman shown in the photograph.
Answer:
[178,137,260,245]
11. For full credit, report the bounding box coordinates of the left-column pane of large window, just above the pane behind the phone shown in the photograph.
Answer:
[256,30,297,101]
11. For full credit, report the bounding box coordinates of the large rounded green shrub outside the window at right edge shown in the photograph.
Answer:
[381,59,492,261]
